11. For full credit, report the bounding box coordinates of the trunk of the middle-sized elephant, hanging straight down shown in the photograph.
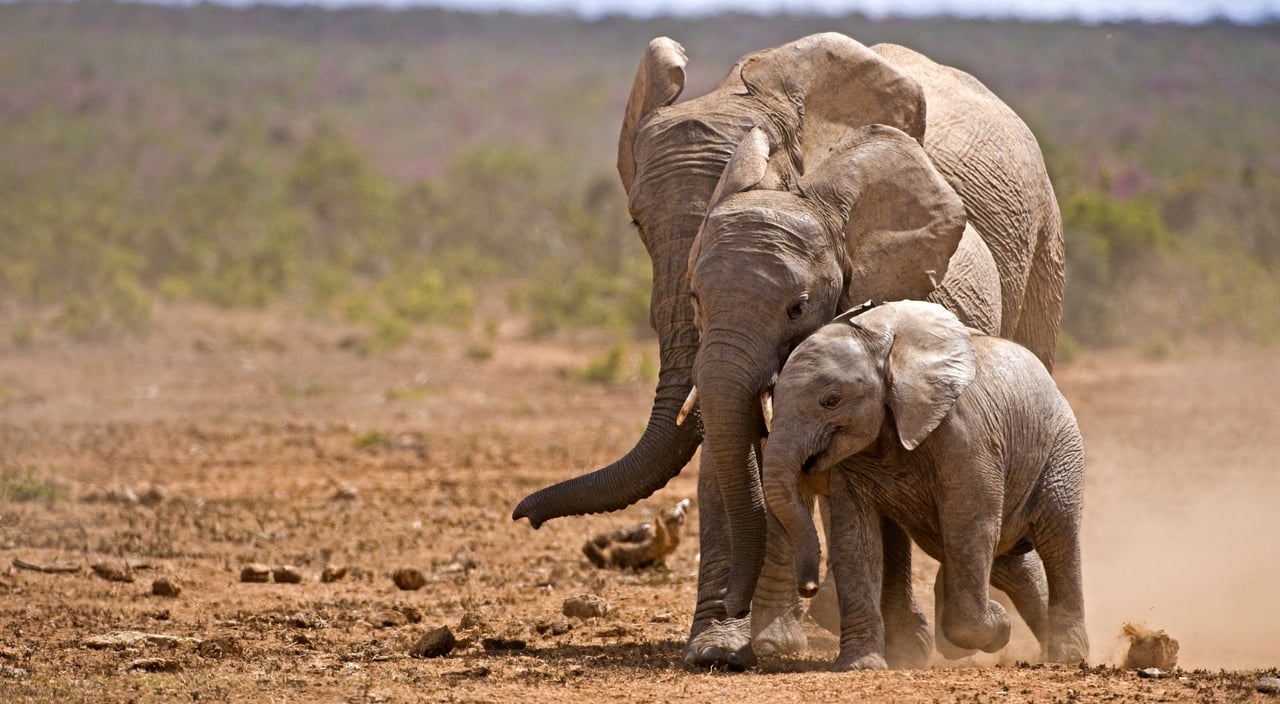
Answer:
[698,344,765,618]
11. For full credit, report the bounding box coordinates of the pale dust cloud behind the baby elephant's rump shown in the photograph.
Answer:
[1059,351,1280,669]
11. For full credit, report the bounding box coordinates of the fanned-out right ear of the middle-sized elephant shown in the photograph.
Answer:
[800,124,966,301]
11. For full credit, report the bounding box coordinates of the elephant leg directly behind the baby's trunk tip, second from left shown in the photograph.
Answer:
[751,500,813,655]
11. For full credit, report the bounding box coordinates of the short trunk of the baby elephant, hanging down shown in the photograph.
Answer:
[763,429,822,596]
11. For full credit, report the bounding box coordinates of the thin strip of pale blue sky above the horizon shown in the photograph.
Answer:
[249,0,1280,23]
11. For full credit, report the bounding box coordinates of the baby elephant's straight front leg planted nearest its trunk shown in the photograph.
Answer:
[828,477,888,671]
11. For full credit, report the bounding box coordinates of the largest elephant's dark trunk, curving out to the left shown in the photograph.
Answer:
[511,292,701,529]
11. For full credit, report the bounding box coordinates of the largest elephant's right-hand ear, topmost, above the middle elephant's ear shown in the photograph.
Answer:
[741,32,924,173]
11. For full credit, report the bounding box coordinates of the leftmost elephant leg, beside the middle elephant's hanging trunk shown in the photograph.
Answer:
[684,448,755,669]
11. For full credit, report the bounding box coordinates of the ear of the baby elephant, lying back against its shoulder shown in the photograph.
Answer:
[850,301,977,449]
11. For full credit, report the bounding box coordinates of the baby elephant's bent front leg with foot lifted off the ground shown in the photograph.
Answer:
[934,486,1010,653]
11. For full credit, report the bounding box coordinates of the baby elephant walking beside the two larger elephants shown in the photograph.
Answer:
[764,301,1089,669]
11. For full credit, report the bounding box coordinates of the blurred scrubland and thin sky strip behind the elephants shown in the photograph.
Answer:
[0,0,1280,361]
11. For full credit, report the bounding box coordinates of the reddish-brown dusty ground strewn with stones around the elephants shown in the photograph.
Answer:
[0,308,1280,701]
